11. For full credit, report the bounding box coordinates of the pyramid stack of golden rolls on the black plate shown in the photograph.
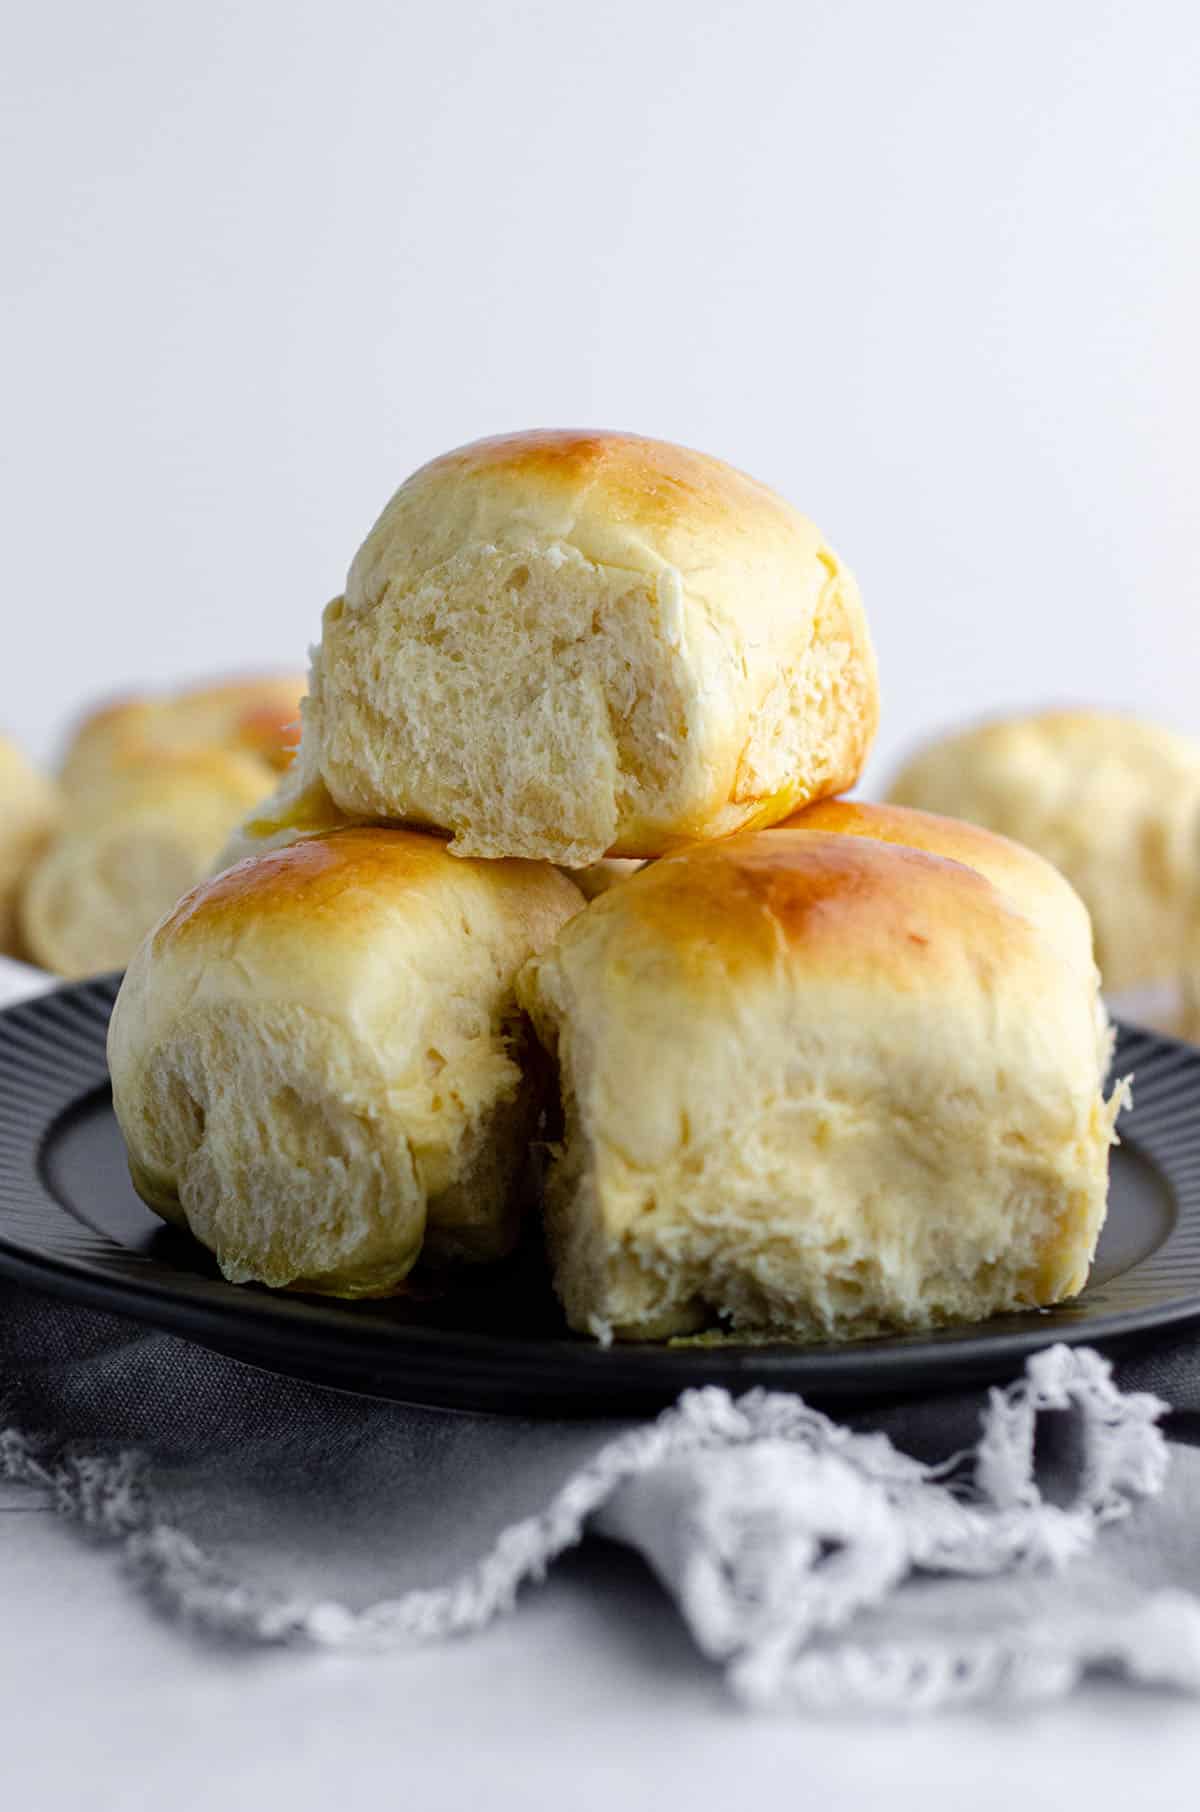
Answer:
[109,433,1120,1339]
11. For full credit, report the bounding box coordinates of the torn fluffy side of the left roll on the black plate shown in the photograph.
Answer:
[121,1004,540,1297]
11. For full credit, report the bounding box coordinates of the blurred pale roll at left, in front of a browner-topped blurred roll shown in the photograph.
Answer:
[20,748,265,975]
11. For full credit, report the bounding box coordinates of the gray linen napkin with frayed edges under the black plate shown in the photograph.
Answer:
[0,977,1200,1711]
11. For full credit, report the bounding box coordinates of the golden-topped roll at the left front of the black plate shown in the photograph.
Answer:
[109,828,582,1296]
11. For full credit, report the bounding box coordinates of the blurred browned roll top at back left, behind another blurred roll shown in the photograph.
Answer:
[60,674,305,792]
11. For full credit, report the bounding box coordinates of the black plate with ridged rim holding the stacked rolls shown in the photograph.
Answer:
[0,977,1200,1413]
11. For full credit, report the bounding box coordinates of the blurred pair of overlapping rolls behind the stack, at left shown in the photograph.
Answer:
[20,678,305,975]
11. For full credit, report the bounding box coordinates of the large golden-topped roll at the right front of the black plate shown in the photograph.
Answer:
[517,830,1122,1339]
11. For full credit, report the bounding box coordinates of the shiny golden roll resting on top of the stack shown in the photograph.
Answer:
[305,431,877,868]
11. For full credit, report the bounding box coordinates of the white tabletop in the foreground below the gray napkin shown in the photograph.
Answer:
[0,1488,1200,1812]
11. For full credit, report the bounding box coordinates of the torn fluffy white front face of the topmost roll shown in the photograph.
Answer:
[312,545,702,866]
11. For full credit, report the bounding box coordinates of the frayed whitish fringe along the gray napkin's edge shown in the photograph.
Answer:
[0,1346,1200,1711]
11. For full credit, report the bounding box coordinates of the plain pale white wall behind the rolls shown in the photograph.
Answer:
[0,0,1200,781]
